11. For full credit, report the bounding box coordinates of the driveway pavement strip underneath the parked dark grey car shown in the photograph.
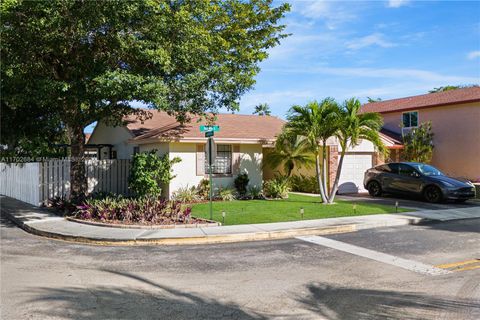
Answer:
[337,193,480,210]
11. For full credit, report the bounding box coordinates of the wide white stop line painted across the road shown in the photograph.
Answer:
[297,236,451,276]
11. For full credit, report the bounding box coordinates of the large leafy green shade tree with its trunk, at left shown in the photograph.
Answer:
[0,0,289,197]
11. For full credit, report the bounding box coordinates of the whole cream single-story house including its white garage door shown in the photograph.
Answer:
[89,110,401,196]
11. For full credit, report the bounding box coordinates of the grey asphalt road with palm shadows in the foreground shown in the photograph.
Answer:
[1,214,480,320]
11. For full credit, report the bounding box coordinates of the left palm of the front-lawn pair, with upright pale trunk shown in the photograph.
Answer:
[286,98,340,204]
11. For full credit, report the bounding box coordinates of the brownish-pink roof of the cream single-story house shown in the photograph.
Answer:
[125,110,285,141]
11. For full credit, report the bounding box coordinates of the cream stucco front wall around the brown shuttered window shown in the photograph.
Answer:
[169,142,263,196]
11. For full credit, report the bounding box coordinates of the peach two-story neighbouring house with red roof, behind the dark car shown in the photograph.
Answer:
[362,87,480,181]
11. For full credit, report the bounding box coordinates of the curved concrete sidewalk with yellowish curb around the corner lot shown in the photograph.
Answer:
[0,196,480,245]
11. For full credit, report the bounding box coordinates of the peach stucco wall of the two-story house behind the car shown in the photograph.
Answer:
[383,102,480,181]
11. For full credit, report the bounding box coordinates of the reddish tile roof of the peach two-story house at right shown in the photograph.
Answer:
[362,87,480,113]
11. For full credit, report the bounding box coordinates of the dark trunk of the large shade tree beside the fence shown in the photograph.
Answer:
[68,126,88,201]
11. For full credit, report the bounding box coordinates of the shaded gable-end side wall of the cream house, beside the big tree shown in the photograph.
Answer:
[88,122,133,159]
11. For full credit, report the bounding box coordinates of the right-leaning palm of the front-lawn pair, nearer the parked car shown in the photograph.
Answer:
[329,98,386,202]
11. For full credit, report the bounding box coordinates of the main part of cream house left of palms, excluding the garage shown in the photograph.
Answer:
[89,110,285,196]
